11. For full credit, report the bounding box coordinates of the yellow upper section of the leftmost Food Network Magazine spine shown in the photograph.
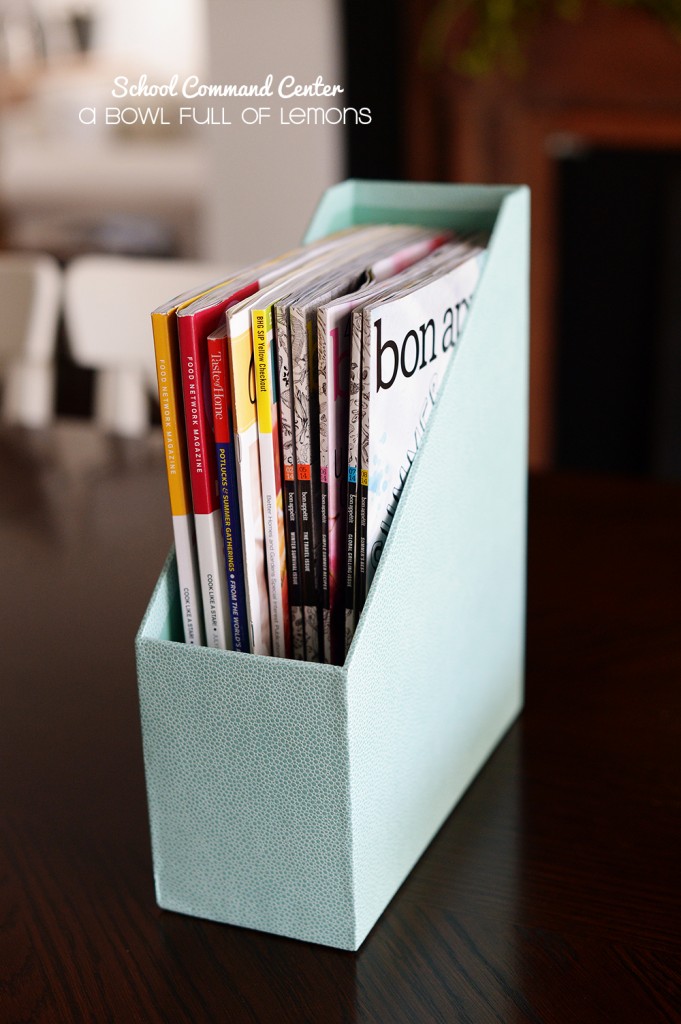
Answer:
[152,311,191,515]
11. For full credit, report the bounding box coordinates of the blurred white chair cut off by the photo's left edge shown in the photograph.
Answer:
[0,252,61,427]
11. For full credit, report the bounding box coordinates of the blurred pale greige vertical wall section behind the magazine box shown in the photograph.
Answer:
[201,0,344,262]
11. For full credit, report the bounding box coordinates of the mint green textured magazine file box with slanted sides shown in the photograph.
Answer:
[136,181,528,949]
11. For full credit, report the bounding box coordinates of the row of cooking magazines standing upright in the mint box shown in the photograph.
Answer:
[152,225,484,665]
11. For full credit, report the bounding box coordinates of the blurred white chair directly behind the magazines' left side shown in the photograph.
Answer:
[65,255,230,437]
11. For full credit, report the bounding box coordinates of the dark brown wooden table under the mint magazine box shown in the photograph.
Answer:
[0,425,681,1024]
